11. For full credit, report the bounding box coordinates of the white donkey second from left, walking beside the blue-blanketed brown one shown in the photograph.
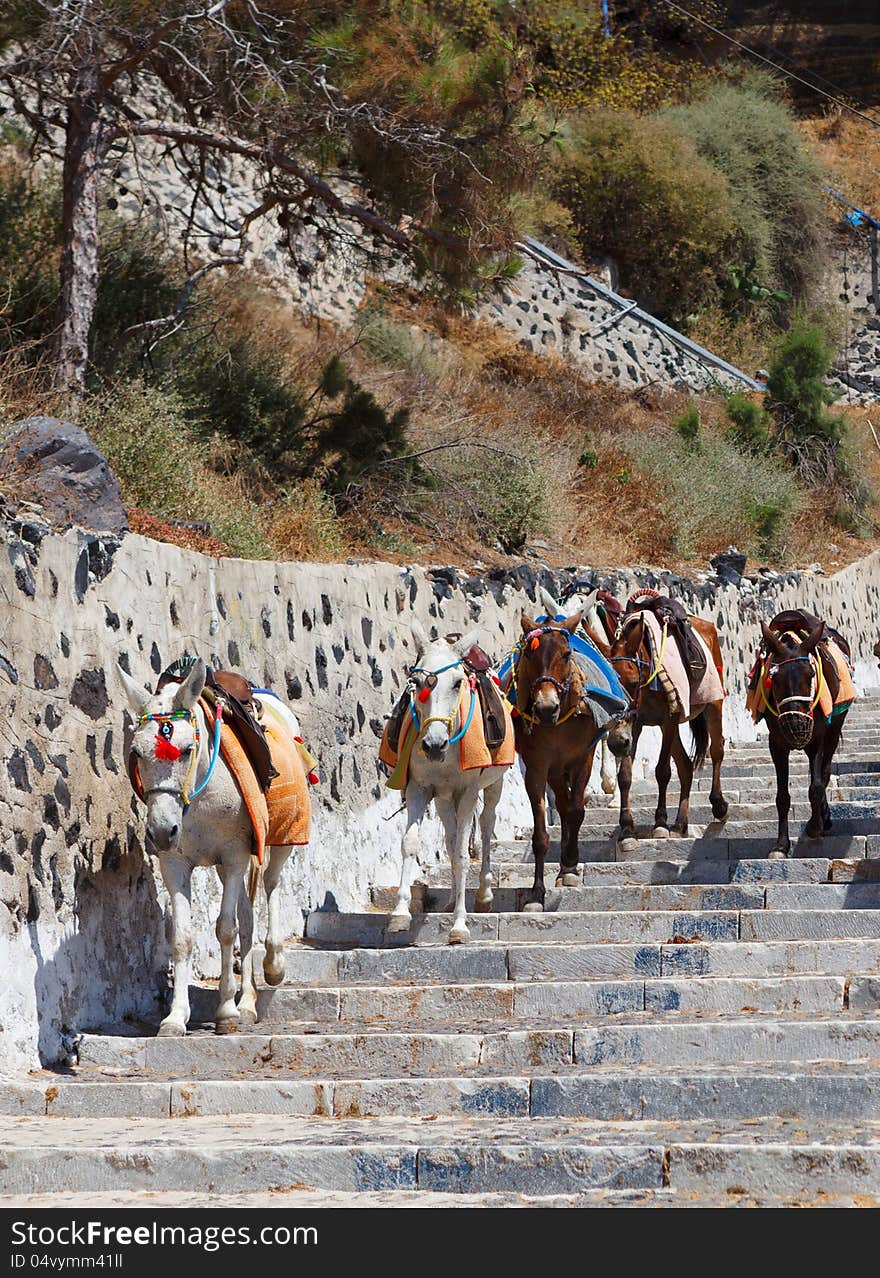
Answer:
[388,620,507,944]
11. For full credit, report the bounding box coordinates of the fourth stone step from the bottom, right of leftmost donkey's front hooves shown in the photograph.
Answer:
[178,975,858,1032]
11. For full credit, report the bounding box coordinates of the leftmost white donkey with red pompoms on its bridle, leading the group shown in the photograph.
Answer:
[119,659,292,1036]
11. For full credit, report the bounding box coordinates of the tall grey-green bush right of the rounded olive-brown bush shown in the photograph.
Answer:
[660,72,825,300]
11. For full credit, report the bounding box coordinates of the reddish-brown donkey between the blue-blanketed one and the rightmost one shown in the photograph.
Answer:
[590,612,728,851]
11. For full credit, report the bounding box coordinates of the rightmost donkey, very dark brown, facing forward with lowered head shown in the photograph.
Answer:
[750,613,849,860]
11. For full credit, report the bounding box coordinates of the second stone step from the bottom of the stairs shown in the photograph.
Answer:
[11,1063,880,1122]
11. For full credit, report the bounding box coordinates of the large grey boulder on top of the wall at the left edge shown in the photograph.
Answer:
[0,417,128,533]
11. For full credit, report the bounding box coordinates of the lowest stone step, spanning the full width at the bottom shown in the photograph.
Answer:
[0,1116,880,1196]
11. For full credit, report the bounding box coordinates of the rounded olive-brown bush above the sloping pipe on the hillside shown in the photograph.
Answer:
[554,111,736,323]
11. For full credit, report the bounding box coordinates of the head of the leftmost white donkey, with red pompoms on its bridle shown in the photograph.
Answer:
[119,658,206,852]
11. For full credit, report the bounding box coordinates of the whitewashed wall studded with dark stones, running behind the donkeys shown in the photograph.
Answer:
[0,524,880,1070]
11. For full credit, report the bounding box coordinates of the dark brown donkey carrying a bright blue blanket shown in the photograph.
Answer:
[513,612,599,910]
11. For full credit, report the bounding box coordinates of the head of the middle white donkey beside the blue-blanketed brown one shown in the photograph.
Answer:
[410,619,479,763]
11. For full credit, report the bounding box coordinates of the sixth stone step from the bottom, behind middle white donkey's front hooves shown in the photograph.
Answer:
[305,909,880,948]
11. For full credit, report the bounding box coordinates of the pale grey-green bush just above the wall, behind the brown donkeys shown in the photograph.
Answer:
[628,432,800,560]
